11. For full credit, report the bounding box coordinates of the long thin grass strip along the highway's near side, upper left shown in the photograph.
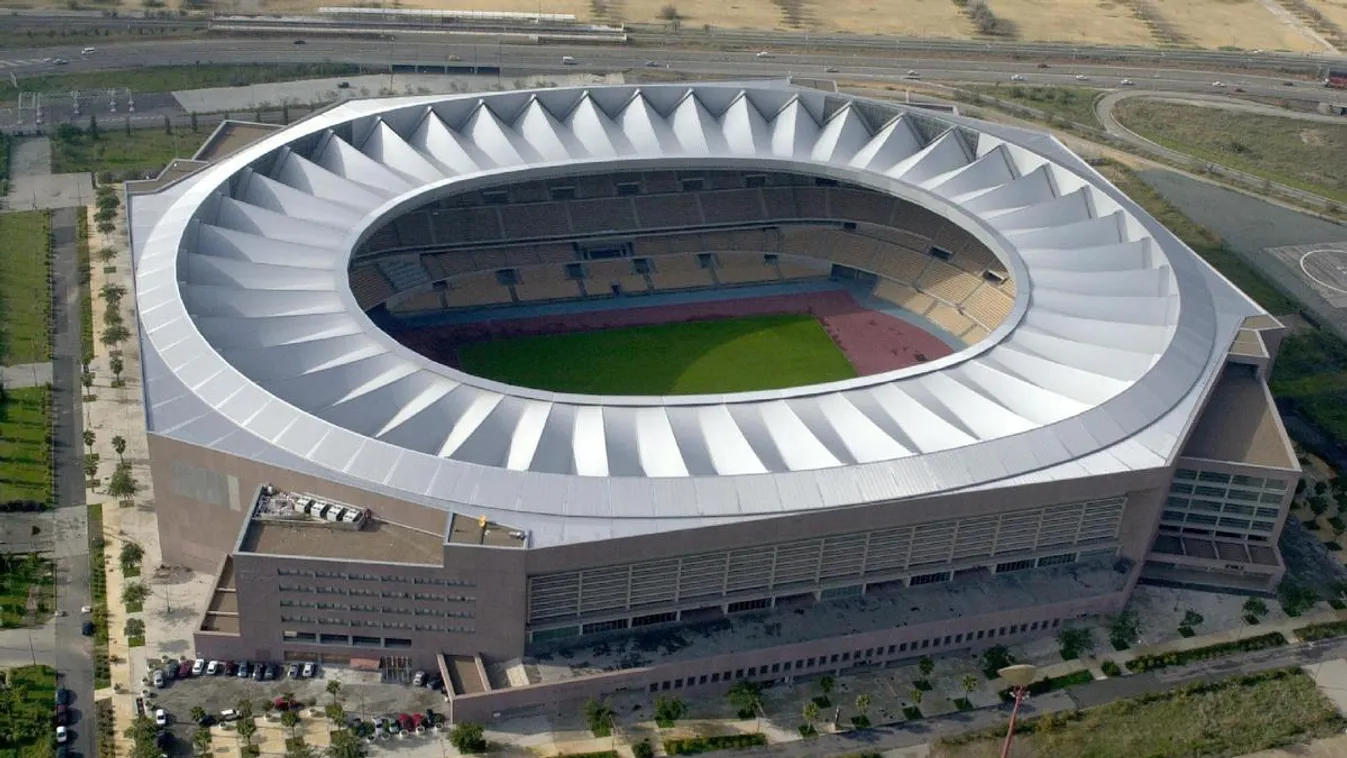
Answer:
[0,63,360,105]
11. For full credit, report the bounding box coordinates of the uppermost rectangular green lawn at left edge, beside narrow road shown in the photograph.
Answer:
[0,210,51,366]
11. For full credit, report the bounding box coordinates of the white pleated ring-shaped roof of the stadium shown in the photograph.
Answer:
[132,82,1261,547]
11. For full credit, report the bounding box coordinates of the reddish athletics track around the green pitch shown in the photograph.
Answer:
[396,291,954,376]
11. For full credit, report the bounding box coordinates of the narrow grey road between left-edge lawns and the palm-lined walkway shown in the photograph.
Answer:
[51,207,97,758]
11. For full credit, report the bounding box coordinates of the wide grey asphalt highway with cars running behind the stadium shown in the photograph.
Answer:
[3,36,1325,105]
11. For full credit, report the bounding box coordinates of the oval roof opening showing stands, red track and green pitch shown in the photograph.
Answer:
[349,168,1016,396]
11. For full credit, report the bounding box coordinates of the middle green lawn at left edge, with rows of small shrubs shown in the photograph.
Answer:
[0,386,51,505]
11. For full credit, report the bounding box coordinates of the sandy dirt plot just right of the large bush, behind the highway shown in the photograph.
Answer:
[987,0,1154,44]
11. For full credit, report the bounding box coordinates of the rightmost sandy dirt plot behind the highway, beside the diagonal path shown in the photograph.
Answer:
[1152,0,1319,53]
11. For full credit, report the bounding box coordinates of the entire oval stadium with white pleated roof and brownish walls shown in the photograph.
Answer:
[129,81,1299,719]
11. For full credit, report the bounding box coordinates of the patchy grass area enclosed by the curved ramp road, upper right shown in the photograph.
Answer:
[1117,98,1347,208]
